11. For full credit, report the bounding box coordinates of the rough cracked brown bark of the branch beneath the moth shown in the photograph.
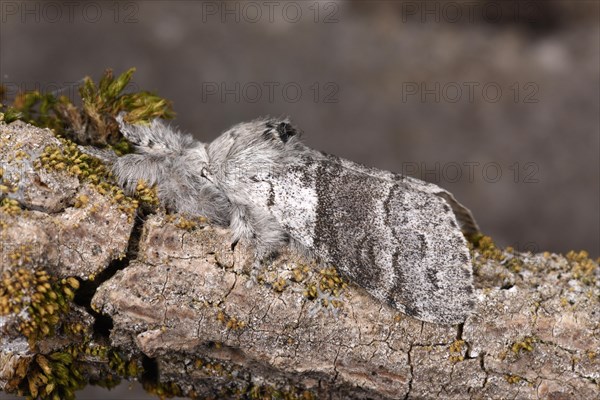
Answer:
[0,123,600,399]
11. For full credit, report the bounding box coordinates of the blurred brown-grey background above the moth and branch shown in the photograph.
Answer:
[0,0,600,398]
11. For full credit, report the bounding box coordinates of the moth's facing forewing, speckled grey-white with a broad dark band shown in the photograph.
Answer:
[262,158,473,324]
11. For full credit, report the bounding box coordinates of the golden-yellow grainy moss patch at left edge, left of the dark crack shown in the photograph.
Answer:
[0,268,79,346]
